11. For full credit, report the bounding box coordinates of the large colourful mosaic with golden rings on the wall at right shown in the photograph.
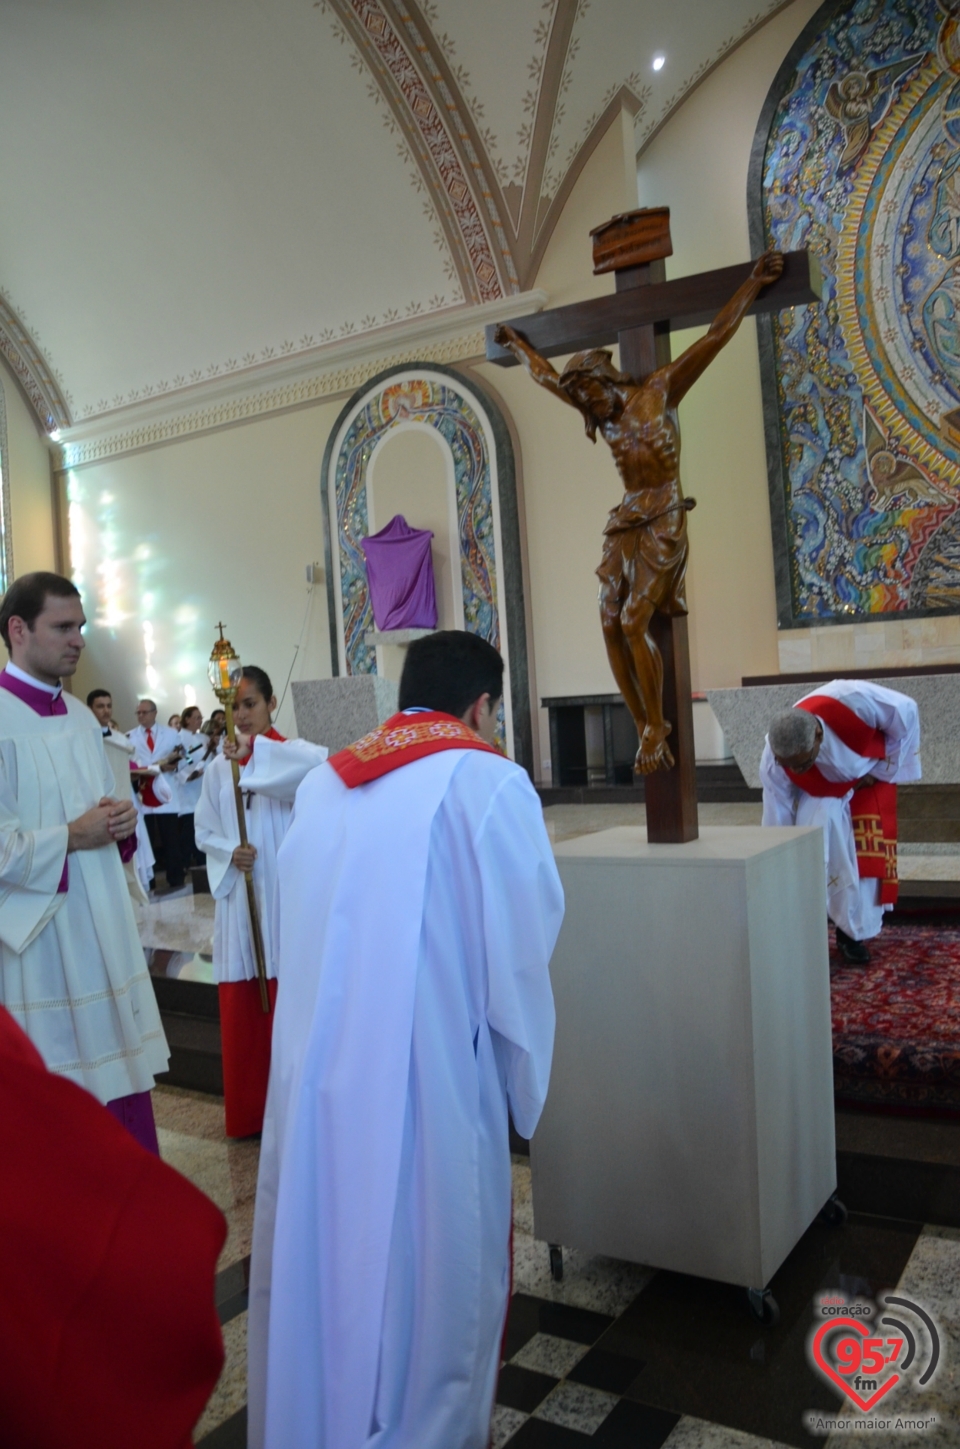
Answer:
[762,0,960,625]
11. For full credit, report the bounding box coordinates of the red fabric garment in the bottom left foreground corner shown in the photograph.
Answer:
[0,1009,226,1449]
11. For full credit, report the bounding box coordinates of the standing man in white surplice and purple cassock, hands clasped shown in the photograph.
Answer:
[0,574,169,1152]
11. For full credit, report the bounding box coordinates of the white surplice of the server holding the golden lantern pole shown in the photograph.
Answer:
[194,735,327,981]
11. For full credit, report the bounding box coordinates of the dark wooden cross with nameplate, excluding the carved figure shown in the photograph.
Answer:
[487,207,821,845]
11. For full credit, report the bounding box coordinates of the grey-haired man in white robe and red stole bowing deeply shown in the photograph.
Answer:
[760,680,921,965]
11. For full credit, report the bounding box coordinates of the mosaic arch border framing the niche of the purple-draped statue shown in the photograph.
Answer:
[320,362,533,771]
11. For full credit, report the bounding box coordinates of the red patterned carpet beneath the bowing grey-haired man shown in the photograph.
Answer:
[830,926,960,1114]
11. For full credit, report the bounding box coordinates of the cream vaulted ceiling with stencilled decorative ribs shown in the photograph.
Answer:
[0,0,783,429]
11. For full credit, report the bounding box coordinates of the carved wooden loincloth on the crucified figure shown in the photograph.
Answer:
[597,498,696,617]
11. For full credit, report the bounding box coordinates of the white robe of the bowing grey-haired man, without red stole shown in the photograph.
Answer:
[760,680,921,940]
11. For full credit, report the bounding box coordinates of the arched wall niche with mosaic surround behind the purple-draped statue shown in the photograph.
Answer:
[321,362,533,772]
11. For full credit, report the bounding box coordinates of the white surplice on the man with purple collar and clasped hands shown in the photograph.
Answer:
[0,690,169,1103]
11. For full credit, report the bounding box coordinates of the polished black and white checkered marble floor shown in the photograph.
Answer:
[153,1088,960,1449]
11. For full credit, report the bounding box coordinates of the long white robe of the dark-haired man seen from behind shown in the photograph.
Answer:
[249,749,563,1449]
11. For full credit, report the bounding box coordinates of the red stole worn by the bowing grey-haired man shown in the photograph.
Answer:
[786,694,899,906]
